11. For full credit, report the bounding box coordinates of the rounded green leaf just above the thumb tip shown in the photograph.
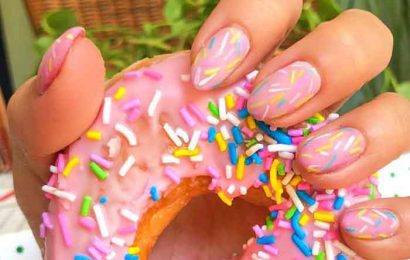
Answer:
[41,9,78,37]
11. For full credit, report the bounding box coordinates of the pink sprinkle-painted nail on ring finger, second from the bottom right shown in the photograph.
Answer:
[297,127,366,173]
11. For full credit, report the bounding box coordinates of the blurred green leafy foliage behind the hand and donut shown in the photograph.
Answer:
[35,0,410,113]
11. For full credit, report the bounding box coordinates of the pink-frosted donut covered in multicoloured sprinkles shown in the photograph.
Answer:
[39,27,383,260]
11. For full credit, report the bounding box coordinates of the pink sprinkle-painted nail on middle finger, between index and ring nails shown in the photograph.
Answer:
[248,61,320,121]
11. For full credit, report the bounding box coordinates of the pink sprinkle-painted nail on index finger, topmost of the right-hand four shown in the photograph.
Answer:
[191,27,250,90]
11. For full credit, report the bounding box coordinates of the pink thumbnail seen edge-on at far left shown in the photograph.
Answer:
[38,27,85,94]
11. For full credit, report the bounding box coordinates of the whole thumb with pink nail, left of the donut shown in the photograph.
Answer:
[8,27,105,157]
